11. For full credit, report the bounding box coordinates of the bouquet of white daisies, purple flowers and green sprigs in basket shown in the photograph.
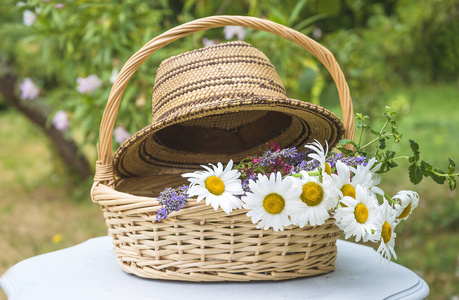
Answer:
[156,108,458,260]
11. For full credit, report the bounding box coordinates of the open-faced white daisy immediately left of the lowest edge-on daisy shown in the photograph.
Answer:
[335,185,382,242]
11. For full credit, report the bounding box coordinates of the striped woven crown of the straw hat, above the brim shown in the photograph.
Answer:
[152,41,287,122]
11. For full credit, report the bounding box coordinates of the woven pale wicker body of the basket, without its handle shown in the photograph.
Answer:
[93,175,339,281]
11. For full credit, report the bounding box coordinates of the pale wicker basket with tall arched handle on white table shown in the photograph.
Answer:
[91,16,354,281]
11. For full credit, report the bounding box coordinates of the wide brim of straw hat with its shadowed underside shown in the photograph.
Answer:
[113,97,344,178]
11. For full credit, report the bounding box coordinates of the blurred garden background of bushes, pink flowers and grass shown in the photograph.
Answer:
[0,0,459,300]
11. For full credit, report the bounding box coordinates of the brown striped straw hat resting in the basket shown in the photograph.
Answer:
[113,41,343,177]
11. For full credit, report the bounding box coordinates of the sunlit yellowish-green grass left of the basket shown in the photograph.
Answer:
[0,110,106,282]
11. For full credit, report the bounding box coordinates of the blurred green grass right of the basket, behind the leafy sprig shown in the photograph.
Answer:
[360,85,459,299]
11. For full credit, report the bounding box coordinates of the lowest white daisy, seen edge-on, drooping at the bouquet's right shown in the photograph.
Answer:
[378,200,397,261]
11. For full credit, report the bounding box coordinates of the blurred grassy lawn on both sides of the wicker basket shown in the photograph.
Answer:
[0,85,459,299]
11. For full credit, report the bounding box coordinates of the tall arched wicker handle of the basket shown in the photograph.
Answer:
[96,16,355,165]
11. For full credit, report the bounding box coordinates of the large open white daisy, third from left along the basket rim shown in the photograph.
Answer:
[290,171,339,228]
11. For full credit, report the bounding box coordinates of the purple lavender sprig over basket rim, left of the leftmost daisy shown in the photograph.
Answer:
[156,185,189,221]
